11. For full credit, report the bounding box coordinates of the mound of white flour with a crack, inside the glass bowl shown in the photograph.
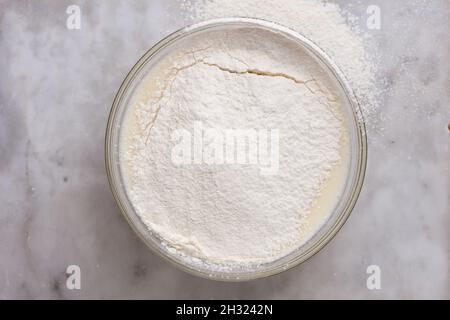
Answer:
[121,28,348,266]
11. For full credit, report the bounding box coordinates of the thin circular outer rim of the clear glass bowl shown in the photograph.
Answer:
[104,17,368,282]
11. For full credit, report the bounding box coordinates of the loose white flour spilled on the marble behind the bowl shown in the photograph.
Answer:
[179,0,383,121]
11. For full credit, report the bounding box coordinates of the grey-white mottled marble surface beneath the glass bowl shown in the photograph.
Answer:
[0,0,450,299]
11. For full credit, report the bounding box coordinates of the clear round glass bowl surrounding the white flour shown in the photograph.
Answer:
[105,18,367,281]
